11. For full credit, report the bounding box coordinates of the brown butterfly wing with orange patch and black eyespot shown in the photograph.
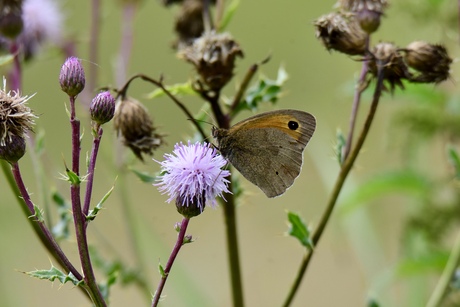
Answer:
[219,110,316,197]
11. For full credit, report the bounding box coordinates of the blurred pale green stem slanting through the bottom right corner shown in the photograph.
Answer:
[426,234,460,307]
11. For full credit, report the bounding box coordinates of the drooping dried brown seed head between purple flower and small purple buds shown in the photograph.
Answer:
[114,98,163,161]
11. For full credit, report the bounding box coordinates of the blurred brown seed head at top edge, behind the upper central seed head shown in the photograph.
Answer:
[175,0,204,50]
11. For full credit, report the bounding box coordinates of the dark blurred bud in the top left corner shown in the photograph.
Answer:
[0,0,24,39]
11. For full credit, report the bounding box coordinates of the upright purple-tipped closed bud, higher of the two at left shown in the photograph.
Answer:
[59,57,86,97]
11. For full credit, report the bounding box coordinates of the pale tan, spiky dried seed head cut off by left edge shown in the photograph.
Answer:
[0,78,36,146]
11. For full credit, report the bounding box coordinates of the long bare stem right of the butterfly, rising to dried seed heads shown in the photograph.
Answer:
[283,66,384,307]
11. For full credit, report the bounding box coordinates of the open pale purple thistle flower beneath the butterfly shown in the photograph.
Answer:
[154,141,230,217]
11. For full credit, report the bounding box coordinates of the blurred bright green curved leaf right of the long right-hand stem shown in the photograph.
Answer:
[340,170,433,214]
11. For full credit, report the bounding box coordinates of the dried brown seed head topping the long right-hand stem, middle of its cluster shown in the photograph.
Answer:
[369,43,412,91]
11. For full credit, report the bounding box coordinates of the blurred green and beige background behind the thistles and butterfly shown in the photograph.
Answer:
[0,0,459,306]
